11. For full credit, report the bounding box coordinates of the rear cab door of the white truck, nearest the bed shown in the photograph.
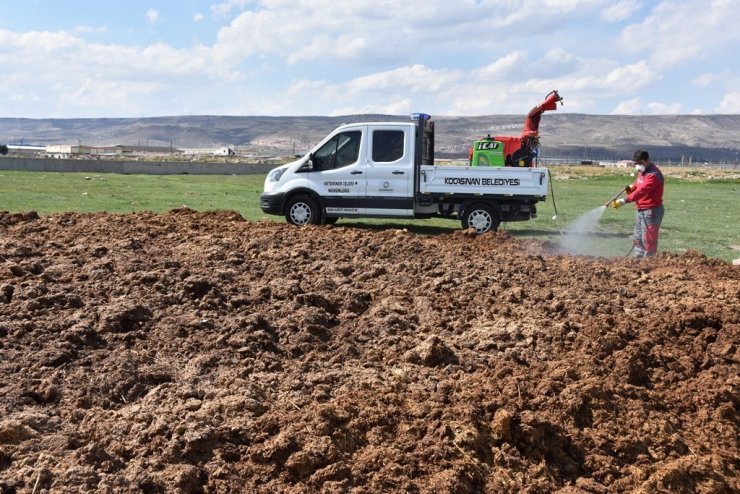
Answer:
[366,125,414,217]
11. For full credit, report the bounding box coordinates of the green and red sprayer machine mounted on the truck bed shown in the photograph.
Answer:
[470,91,563,167]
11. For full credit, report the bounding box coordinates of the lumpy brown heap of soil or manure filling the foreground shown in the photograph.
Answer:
[0,209,740,493]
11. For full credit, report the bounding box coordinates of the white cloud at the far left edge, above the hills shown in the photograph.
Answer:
[0,30,241,116]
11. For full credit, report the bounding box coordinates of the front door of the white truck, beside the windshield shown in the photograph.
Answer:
[309,127,367,216]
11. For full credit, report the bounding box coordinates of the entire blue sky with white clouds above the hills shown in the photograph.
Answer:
[0,0,740,118]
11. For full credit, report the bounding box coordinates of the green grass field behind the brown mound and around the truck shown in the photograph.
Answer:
[0,170,740,261]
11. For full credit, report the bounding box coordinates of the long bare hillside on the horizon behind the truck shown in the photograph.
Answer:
[0,112,740,163]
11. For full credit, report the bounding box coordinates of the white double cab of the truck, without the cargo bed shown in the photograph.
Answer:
[261,117,428,220]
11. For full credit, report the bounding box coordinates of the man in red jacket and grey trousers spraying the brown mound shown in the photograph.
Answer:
[611,150,665,257]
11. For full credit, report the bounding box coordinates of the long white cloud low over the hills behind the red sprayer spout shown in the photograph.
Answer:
[274,49,677,115]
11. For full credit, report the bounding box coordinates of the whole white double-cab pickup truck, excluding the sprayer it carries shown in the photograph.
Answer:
[260,114,549,234]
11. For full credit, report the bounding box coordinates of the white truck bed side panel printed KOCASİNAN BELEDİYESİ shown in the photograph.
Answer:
[419,165,549,198]
